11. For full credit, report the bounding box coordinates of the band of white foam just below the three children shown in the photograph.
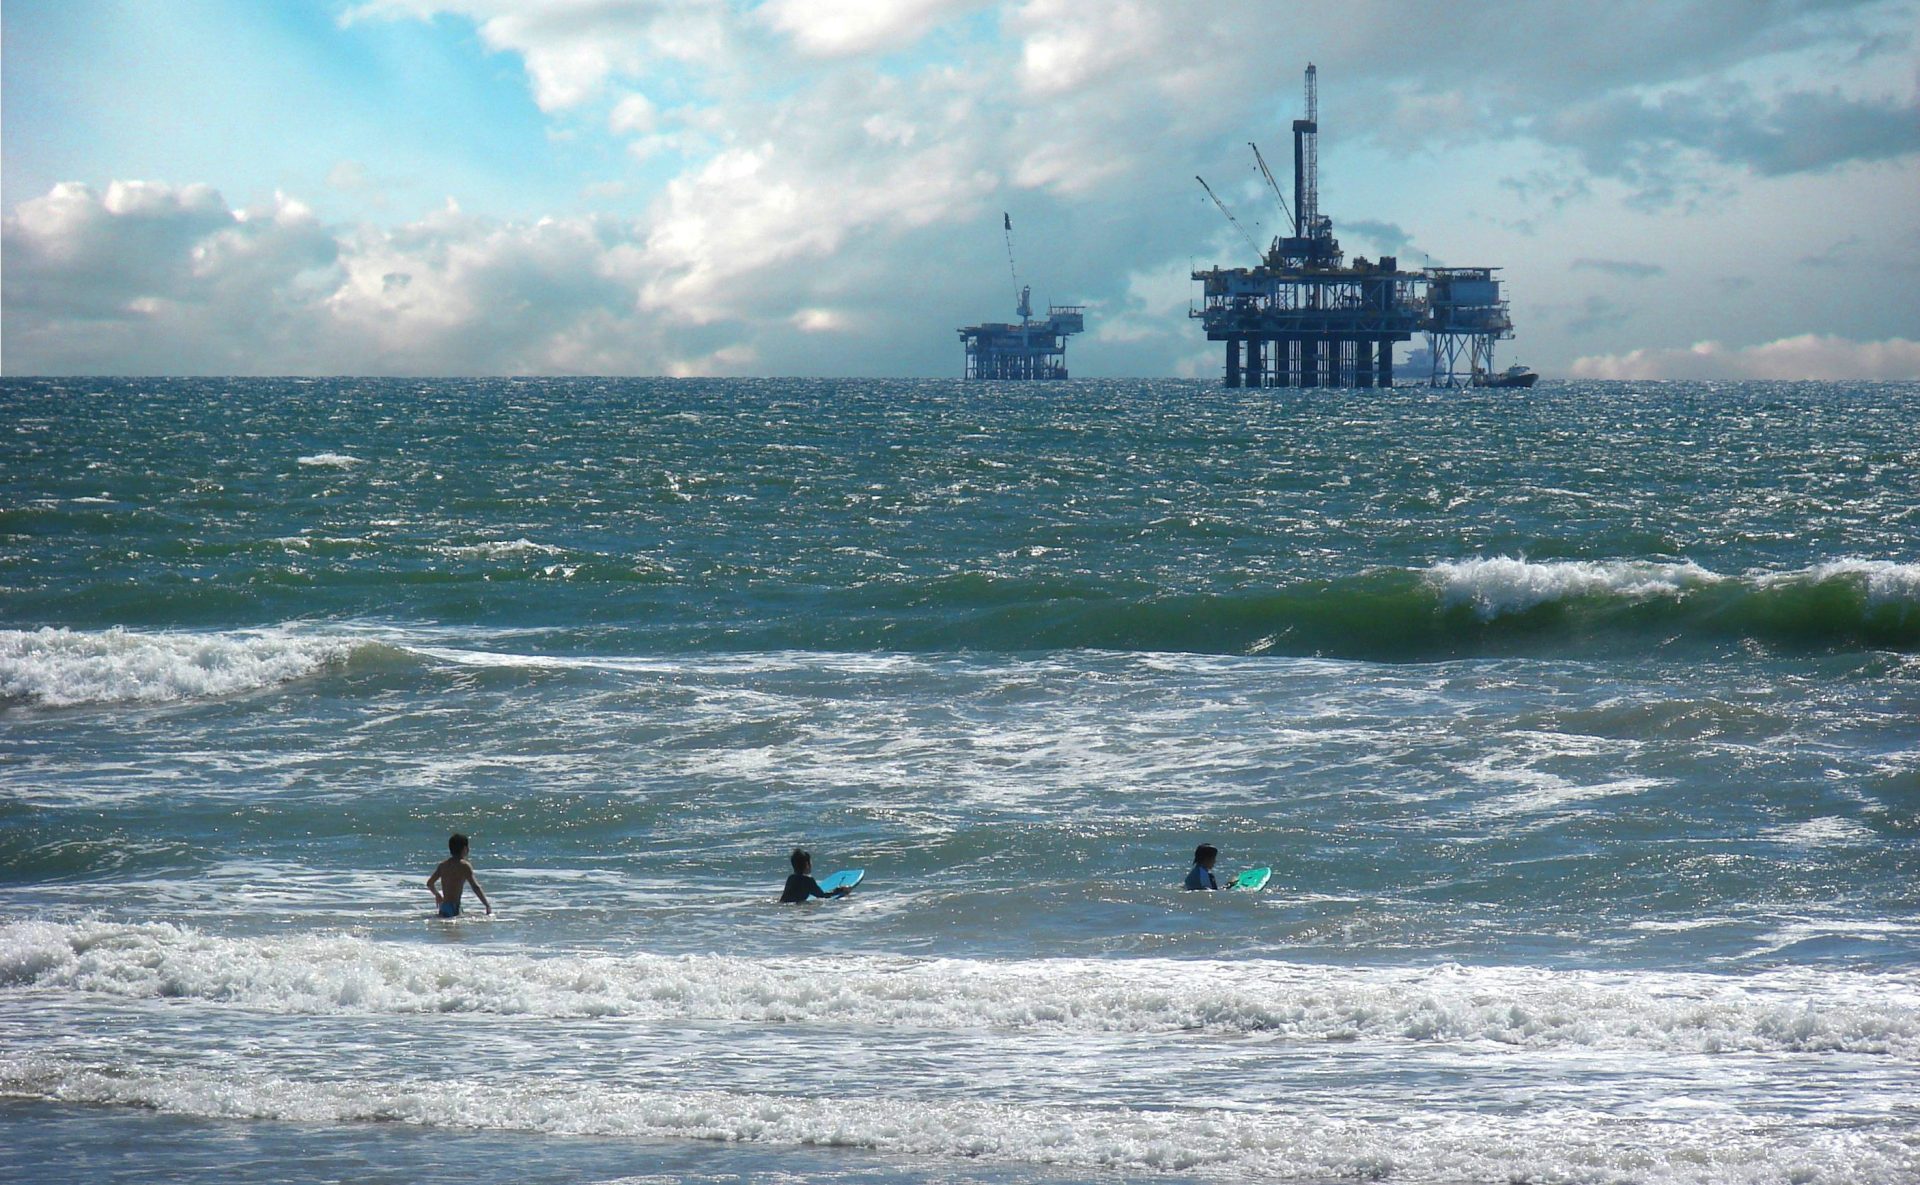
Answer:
[15,922,1920,1056]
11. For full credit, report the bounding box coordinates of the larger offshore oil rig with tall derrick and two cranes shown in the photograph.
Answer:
[1188,63,1536,388]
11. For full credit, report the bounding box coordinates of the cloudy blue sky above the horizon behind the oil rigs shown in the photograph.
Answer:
[0,0,1920,378]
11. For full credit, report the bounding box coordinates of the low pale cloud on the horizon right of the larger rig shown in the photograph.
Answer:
[1569,334,1920,380]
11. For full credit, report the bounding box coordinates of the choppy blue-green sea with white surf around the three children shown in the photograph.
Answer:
[0,380,1920,1185]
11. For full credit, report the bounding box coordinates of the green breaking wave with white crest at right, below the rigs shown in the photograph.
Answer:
[825,557,1920,661]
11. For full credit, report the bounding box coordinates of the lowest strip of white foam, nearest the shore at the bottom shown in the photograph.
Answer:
[0,1054,1920,1185]
